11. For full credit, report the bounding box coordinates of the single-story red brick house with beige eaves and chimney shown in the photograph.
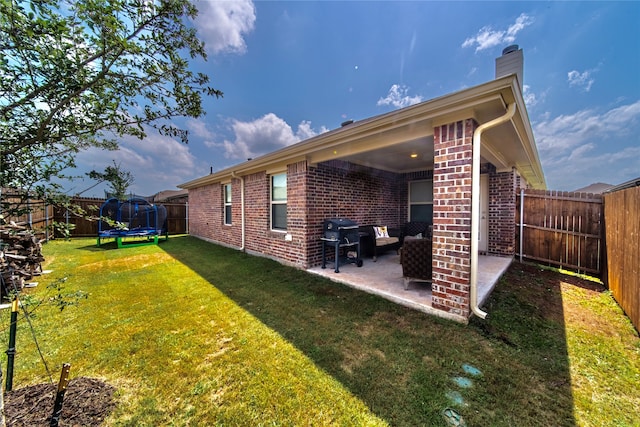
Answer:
[180,47,546,321]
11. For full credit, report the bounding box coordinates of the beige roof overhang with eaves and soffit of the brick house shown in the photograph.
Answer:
[178,74,546,189]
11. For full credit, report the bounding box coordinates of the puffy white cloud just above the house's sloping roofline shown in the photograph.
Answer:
[214,113,327,159]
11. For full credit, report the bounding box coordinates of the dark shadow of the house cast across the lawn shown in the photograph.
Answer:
[160,237,575,426]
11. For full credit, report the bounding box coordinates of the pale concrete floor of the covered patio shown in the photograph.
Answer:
[307,252,513,320]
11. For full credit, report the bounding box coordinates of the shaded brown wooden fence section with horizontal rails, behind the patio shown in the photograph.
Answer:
[516,189,605,276]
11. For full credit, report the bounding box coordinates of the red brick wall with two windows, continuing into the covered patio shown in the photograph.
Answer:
[189,161,406,268]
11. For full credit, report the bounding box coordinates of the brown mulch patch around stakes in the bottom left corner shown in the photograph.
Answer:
[4,377,115,427]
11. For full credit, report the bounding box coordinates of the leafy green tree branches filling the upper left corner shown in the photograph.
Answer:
[0,0,222,219]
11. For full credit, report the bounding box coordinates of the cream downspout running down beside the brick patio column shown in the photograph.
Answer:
[470,102,516,319]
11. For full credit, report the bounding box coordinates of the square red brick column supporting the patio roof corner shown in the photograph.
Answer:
[432,119,477,319]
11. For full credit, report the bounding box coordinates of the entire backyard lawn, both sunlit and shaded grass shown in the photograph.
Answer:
[3,236,640,426]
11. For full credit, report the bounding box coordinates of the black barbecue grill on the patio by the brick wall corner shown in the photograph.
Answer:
[322,218,362,273]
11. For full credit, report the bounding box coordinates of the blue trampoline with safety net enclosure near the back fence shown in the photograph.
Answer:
[98,197,169,248]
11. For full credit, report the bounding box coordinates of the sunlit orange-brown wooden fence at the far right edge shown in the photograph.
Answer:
[604,187,640,331]
